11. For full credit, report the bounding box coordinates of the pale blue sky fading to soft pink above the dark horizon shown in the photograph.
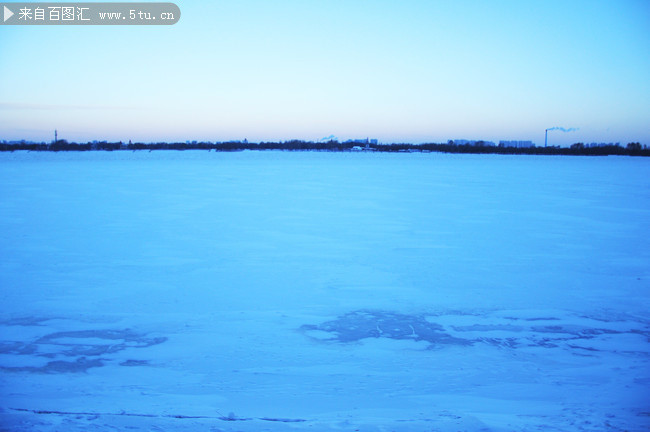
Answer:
[0,0,650,145]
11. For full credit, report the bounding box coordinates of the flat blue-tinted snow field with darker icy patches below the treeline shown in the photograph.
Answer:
[0,151,650,432]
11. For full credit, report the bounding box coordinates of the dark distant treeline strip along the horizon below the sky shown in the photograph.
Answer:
[0,140,650,156]
